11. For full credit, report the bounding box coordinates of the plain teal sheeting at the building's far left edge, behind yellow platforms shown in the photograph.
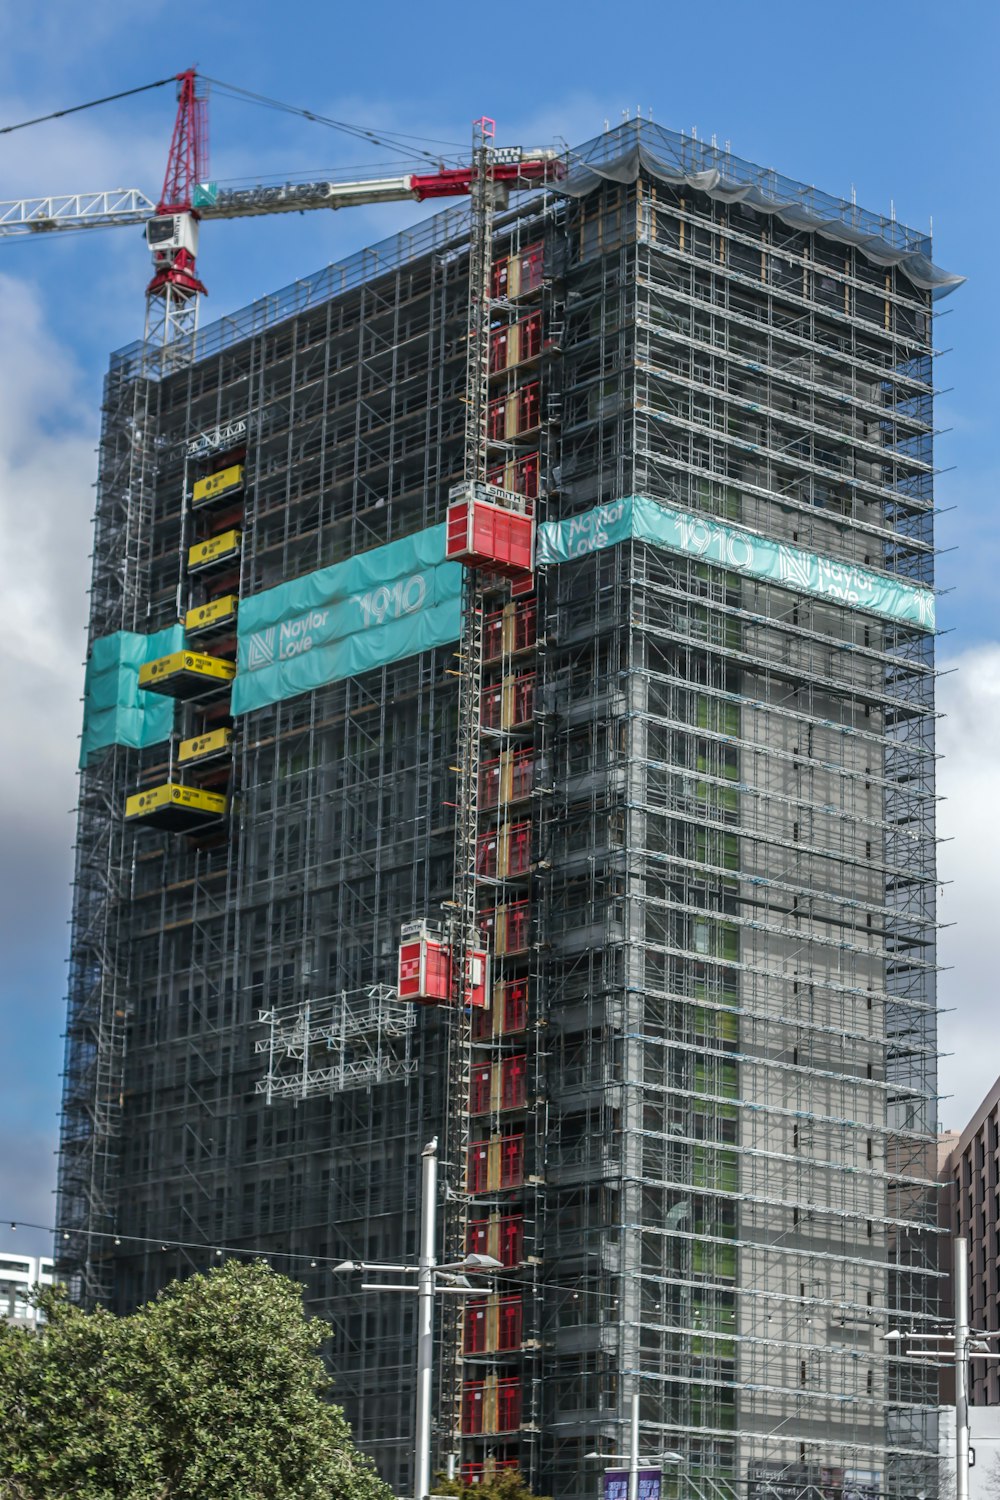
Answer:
[79,626,184,767]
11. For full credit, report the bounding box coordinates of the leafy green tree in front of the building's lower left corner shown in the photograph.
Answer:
[0,1262,391,1500]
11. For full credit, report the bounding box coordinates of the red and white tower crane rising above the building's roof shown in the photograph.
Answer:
[0,68,562,347]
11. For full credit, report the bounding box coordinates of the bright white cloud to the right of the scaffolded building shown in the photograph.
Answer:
[939,644,1000,1130]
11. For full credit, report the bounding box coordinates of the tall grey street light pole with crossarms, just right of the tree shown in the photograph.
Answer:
[333,1136,500,1500]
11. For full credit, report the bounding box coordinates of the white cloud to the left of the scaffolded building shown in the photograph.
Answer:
[0,275,92,1008]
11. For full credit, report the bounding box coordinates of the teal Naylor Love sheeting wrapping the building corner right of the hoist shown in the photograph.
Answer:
[535,495,934,630]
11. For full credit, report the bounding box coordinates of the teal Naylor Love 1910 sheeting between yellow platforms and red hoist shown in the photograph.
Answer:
[232,527,462,714]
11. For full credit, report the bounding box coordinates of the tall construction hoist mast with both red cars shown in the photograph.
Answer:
[399,119,537,1469]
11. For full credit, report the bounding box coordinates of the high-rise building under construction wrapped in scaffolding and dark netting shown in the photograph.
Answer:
[60,122,955,1500]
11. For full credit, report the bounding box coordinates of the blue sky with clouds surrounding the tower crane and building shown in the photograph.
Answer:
[0,0,1000,1248]
